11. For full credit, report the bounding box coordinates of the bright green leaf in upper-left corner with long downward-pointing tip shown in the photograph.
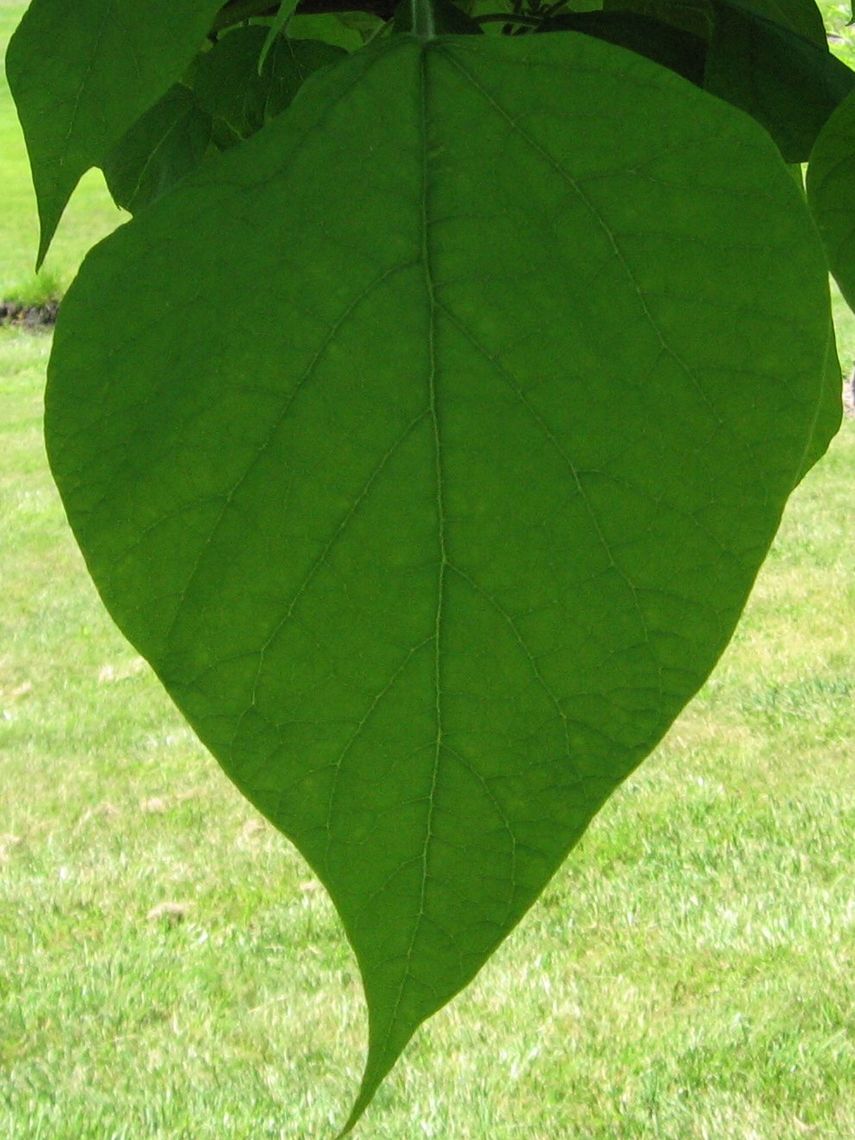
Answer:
[6,0,220,268]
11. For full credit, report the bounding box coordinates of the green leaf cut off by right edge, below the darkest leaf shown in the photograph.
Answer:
[807,86,855,309]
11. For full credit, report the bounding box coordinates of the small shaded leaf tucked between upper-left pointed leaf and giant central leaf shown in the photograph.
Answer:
[103,83,211,213]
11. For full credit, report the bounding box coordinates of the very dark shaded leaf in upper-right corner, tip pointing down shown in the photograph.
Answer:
[705,2,855,162]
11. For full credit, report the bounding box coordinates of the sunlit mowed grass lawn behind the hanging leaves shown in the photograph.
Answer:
[0,0,855,1140]
